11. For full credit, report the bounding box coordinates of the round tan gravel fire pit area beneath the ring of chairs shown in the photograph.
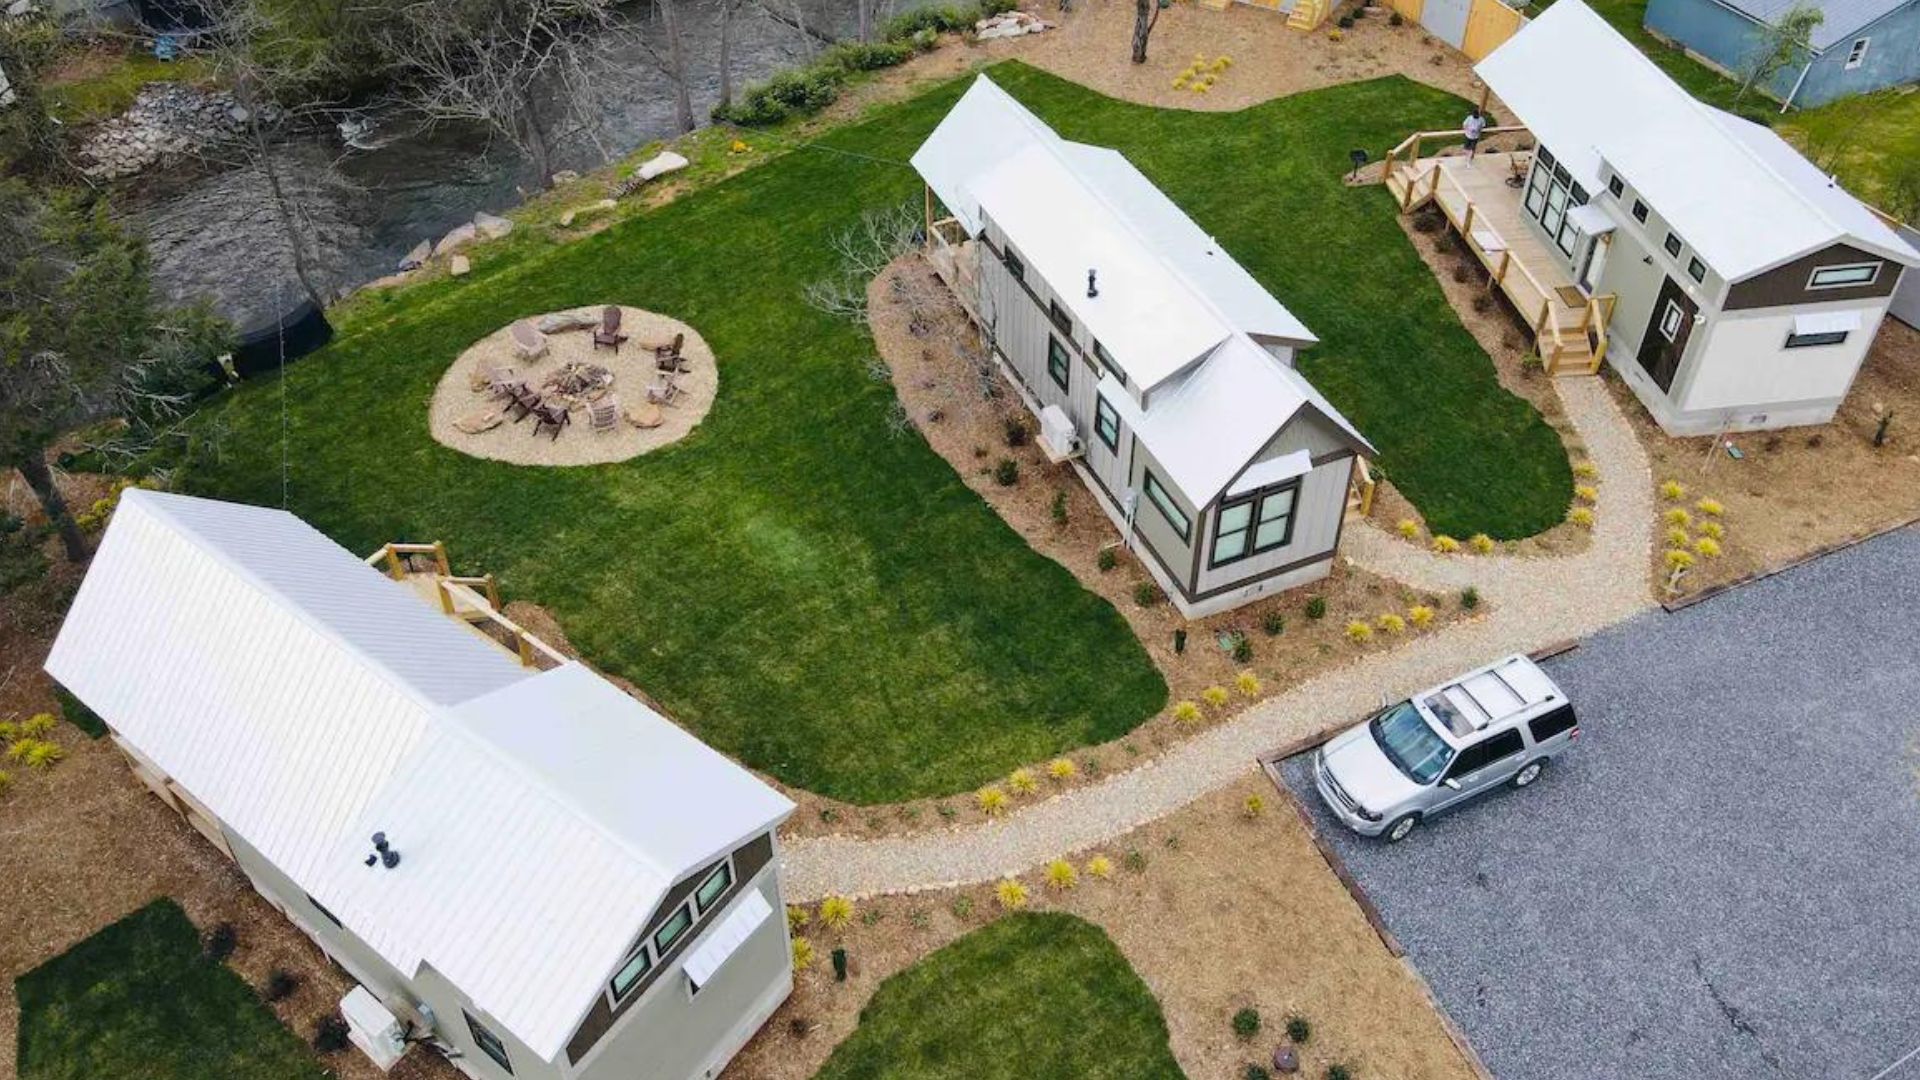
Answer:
[428,307,720,465]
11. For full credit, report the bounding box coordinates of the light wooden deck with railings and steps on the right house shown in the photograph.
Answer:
[1386,129,1615,375]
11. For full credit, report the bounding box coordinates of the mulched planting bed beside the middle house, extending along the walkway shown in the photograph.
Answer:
[783,256,1473,836]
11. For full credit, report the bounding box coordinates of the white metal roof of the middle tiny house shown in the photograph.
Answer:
[914,77,1373,505]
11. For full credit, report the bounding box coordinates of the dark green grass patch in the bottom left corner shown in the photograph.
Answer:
[13,899,326,1080]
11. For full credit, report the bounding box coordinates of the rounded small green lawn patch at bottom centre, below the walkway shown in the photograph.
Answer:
[814,913,1183,1080]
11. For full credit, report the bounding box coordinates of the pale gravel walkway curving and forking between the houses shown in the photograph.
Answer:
[783,379,1653,901]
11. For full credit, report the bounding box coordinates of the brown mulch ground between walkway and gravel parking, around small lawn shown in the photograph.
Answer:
[726,776,1475,1080]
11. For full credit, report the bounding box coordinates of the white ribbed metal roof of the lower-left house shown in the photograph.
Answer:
[46,490,793,1061]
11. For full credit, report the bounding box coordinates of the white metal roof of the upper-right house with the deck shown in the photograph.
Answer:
[1475,0,1920,281]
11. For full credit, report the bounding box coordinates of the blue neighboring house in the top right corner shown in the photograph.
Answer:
[1645,0,1920,108]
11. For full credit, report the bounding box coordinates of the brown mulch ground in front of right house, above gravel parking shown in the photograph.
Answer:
[1607,319,1920,598]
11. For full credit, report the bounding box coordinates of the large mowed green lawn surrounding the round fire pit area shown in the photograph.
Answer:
[188,63,1571,803]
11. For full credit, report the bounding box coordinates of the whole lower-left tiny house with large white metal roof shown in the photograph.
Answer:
[46,490,793,1080]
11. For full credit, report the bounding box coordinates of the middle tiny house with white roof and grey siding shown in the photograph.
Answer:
[914,77,1373,617]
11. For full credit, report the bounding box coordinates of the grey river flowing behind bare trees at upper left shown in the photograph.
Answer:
[131,0,914,325]
